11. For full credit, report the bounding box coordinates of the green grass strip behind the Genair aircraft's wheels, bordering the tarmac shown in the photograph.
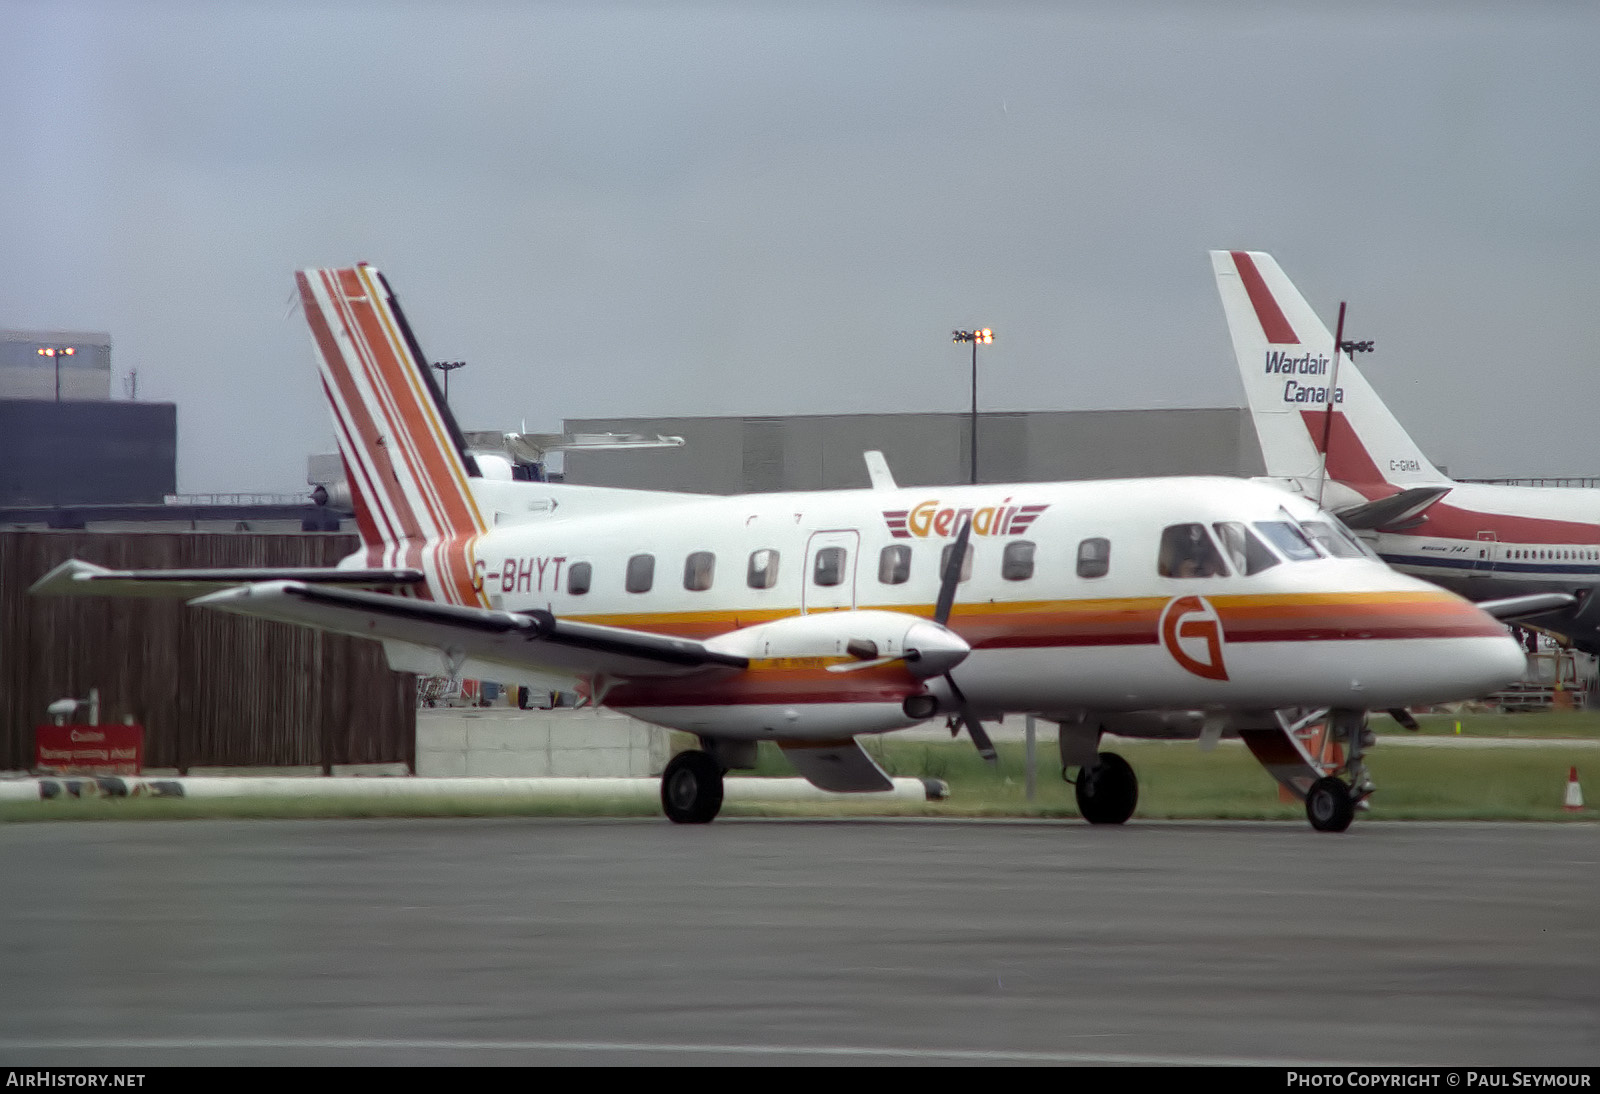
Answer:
[0,737,1600,822]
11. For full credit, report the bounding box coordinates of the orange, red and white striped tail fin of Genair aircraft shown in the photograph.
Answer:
[294,264,486,605]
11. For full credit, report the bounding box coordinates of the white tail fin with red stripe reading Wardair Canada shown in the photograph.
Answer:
[1211,251,1448,486]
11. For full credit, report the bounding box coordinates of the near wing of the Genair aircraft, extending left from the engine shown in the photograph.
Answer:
[192,581,749,680]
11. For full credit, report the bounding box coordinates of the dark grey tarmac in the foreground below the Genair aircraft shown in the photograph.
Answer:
[0,819,1600,1067]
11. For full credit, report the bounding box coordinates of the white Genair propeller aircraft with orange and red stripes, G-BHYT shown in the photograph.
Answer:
[35,266,1523,830]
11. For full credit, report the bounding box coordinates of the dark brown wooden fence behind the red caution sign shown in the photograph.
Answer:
[0,531,416,771]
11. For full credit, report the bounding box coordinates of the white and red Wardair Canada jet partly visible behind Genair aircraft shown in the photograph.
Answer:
[1211,251,1600,653]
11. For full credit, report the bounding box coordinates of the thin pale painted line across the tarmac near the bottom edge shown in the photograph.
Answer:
[0,1038,1355,1067]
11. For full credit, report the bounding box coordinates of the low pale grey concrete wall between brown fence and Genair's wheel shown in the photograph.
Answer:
[416,707,669,777]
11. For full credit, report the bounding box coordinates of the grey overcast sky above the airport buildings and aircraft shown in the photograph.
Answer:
[0,0,1600,491]
